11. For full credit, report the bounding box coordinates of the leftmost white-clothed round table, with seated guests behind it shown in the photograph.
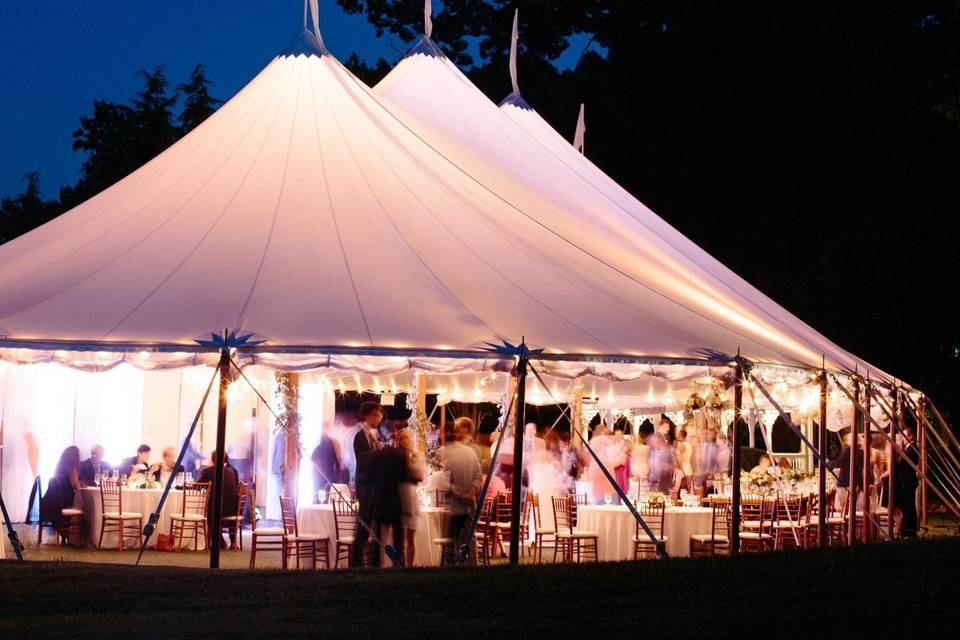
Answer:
[74,487,206,549]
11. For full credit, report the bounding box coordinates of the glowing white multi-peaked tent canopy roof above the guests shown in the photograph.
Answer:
[0,25,900,384]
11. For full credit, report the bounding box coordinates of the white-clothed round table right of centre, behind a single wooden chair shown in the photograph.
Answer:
[577,505,713,561]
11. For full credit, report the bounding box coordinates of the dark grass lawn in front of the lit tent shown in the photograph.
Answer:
[0,539,960,640]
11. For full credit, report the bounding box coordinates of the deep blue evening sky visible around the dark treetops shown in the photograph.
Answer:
[0,0,582,197]
